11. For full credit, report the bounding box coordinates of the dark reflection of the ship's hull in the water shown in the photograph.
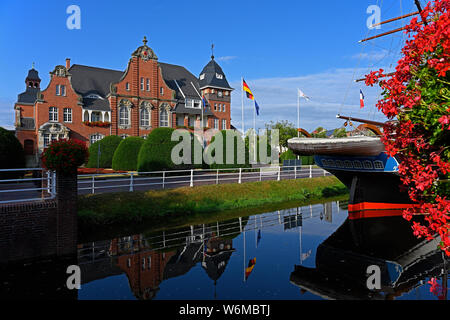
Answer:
[290,212,448,299]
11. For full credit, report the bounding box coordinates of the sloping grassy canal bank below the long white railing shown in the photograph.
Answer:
[78,177,348,239]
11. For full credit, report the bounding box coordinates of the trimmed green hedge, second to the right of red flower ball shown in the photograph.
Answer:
[112,137,145,171]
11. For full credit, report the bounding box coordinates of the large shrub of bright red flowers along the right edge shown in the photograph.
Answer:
[366,0,450,256]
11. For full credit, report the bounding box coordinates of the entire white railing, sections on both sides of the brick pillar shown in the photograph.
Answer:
[0,166,330,204]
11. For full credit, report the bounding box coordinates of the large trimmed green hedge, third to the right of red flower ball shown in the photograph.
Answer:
[137,128,178,172]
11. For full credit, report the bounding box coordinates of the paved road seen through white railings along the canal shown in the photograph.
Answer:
[0,168,330,201]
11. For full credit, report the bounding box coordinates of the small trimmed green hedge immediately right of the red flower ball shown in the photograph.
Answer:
[86,136,122,168]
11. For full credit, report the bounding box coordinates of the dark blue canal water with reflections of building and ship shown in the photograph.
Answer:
[1,202,448,300]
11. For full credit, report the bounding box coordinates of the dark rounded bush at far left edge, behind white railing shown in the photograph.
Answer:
[0,127,25,179]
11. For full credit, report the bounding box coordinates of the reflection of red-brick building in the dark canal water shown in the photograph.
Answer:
[78,227,237,299]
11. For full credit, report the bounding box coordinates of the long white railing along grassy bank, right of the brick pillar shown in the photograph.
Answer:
[78,165,330,194]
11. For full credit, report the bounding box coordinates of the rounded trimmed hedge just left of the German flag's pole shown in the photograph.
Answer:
[206,130,250,169]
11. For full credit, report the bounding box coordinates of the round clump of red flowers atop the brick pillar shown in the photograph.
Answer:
[42,139,89,173]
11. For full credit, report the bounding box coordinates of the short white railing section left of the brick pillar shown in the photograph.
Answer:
[0,168,56,204]
